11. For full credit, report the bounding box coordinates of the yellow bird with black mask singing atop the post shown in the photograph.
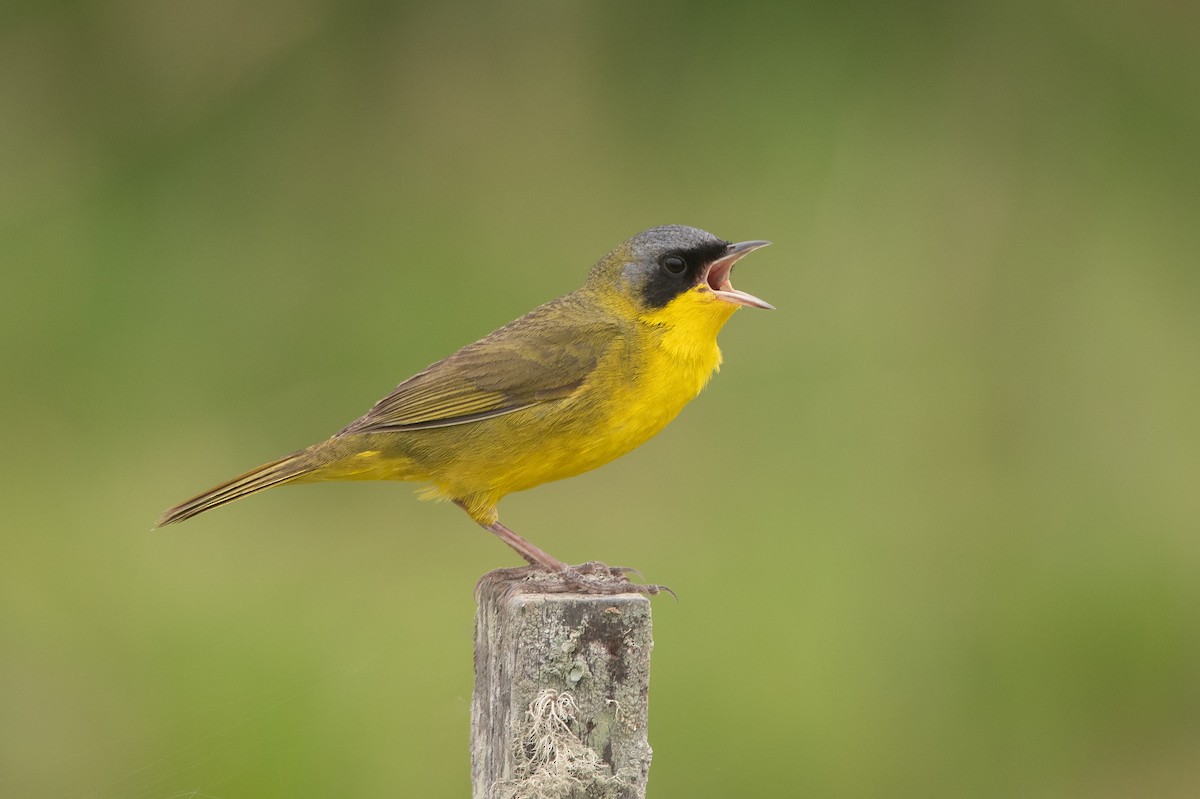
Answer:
[158,226,773,585]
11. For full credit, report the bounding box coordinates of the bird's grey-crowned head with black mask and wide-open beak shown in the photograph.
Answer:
[588,224,774,328]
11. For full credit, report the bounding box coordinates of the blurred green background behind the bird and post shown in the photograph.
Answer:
[0,0,1200,799]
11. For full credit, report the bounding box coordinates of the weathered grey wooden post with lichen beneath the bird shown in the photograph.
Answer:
[470,569,654,799]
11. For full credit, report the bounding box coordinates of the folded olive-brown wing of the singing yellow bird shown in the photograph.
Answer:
[342,300,619,434]
